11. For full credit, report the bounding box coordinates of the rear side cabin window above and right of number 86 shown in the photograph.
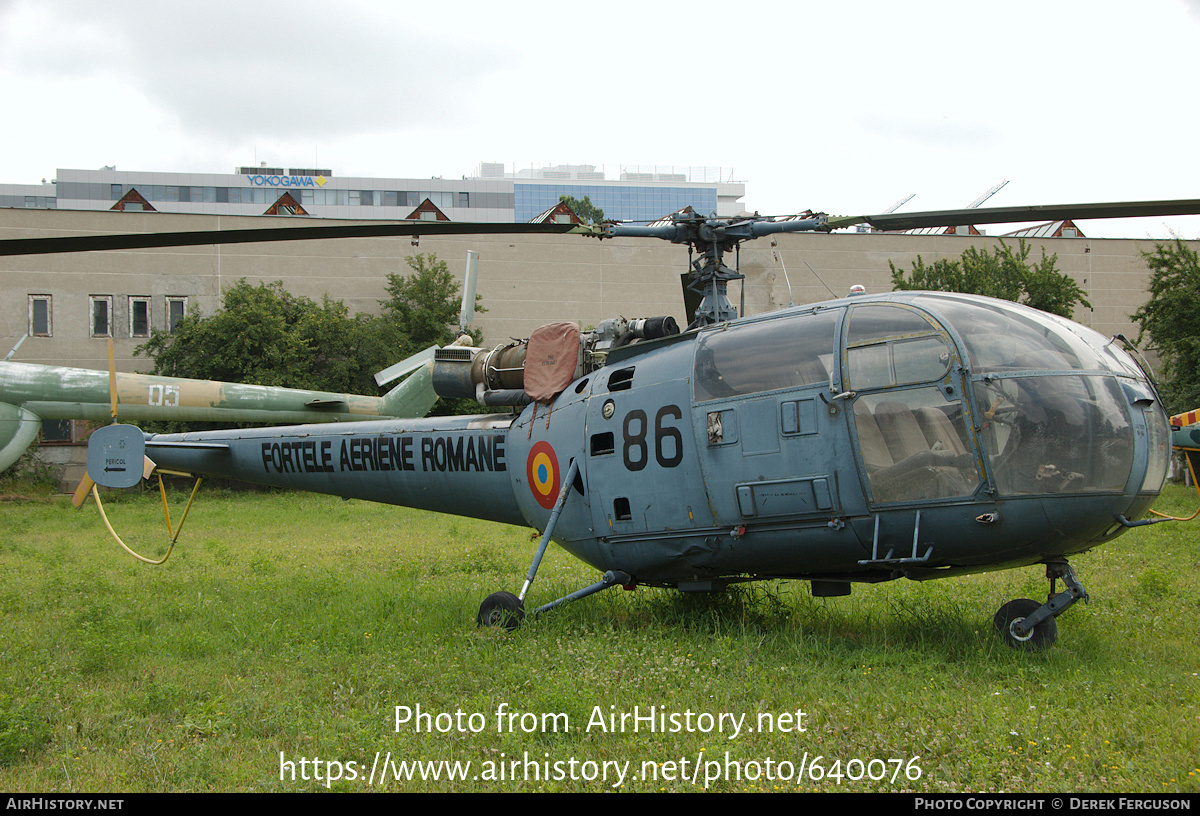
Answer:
[692,310,840,402]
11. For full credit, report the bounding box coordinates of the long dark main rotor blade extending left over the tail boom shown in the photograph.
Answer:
[0,221,577,256]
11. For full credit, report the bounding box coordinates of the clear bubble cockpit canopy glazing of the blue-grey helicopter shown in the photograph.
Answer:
[692,293,1169,503]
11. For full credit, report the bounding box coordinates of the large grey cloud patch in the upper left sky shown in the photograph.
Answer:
[0,0,515,142]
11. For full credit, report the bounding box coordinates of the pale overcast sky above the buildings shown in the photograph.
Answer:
[0,0,1200,238]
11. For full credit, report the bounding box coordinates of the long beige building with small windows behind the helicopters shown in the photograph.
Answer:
[0,209,1176,371]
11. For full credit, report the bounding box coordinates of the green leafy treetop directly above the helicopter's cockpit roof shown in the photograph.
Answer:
[888,240,1092,317]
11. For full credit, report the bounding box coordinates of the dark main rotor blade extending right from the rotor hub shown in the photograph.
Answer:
[826,198,1200,230]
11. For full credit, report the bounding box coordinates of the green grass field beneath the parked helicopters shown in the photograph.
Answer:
[0,487,1200,793]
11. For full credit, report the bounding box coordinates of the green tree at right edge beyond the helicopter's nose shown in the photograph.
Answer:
[1129,238,1200,414]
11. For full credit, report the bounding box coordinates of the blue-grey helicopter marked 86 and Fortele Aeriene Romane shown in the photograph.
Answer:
[0,200,1200,650]
